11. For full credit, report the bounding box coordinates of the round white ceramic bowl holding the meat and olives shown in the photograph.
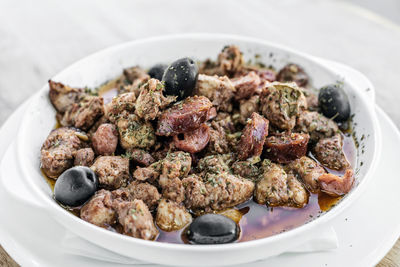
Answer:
[17,34,380,266]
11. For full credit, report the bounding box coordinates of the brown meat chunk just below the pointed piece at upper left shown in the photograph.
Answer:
[60,95,104,131]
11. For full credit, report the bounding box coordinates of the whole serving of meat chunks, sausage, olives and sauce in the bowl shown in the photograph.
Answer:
[41,45,355,244]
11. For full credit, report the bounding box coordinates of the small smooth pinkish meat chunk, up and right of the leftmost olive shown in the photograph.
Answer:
[92,123,118,156]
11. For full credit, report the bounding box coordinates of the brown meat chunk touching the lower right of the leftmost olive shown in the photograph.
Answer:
[80,189,117,228]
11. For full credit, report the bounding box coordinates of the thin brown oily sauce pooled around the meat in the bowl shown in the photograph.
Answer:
[42,77,357,244]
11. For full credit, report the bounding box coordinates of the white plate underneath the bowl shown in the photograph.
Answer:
[0,101,400,267]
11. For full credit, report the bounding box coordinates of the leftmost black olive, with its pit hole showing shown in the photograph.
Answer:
[54,166,99,207]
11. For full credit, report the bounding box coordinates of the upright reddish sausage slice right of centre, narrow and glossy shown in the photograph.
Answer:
[238,112,268,160]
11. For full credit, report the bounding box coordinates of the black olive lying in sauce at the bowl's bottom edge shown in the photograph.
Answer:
[186,214,239,244]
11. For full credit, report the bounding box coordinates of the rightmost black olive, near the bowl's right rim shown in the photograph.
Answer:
[318,84,350,122]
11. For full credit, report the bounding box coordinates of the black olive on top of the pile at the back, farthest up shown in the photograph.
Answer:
[162,57,199,100]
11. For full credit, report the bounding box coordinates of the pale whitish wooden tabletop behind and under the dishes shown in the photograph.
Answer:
[0,0,400,266]
